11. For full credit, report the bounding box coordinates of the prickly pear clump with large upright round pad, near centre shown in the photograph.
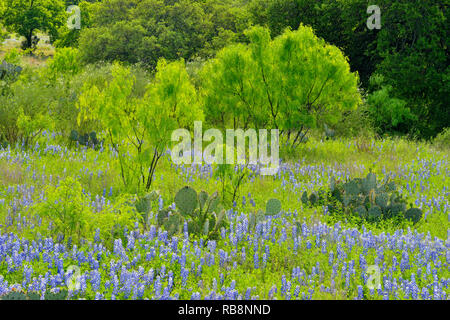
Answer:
[156,186,227,239]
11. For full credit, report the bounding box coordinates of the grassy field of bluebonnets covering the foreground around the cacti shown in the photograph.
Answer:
[0,133,450,299]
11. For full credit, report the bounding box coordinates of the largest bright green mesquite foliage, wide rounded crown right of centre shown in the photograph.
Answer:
[202,26,360,144]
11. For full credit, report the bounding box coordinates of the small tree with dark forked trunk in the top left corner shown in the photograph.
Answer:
[2,0,66,49]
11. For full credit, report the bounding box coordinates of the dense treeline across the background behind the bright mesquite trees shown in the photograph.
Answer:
[0,0,450,138]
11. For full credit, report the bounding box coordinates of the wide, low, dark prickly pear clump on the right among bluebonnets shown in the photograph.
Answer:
[301,173,422,223]
